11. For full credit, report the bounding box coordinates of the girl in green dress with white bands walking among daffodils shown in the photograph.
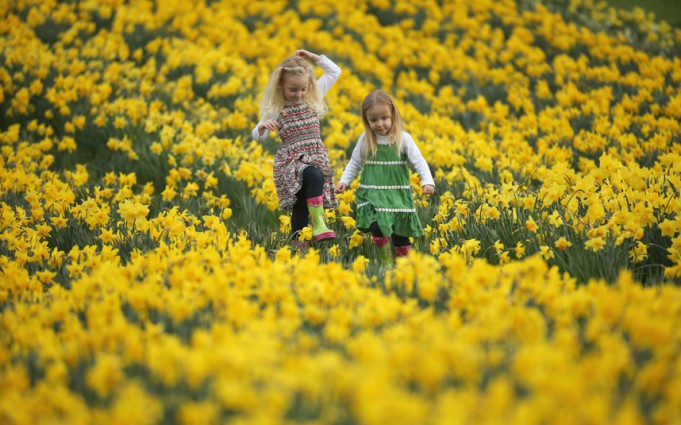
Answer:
[336,90,435,268]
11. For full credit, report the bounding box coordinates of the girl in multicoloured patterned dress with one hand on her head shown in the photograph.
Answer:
[253,50,341,247]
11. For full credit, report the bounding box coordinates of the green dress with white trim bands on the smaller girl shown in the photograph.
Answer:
[355,143,424,237]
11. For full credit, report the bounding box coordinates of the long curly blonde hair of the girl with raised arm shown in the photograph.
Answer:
[260,56,327,118]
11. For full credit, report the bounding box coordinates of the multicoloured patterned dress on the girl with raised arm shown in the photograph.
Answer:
[274,102,338,210]
